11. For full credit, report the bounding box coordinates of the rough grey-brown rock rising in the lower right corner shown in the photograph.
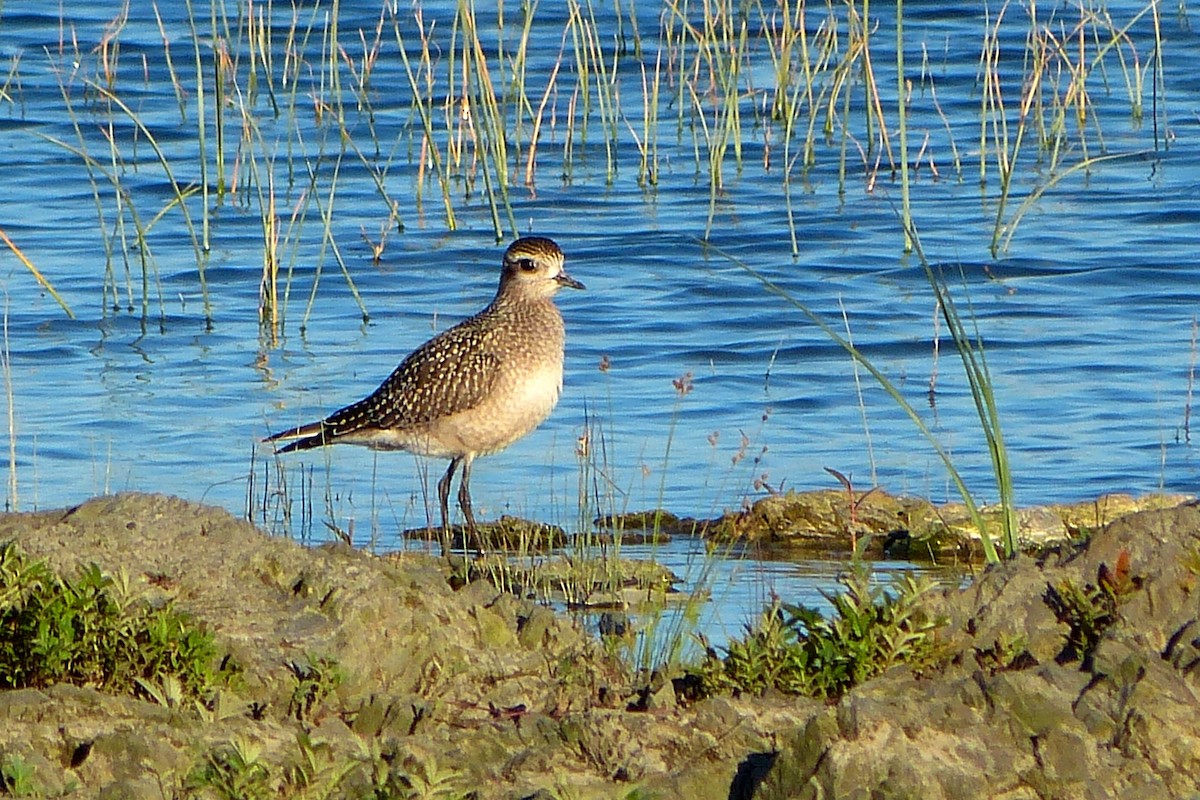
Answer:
[757,503,1200,800]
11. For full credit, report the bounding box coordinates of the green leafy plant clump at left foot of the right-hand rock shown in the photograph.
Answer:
[692,564,941,698]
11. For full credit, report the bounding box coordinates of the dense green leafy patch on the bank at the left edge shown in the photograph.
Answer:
[0,542,216,699]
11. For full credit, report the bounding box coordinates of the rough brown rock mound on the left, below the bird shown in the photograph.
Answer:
[0,494,815,799]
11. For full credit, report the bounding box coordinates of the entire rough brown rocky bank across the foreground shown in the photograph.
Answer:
[0,494,1200,799]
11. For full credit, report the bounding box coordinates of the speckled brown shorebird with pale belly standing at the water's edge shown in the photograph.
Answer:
[266,236,583,555]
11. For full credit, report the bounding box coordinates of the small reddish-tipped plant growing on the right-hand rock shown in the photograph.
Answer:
[1043,551,1141,672]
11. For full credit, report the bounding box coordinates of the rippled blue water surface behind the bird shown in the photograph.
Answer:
[0,1,1200,638]
